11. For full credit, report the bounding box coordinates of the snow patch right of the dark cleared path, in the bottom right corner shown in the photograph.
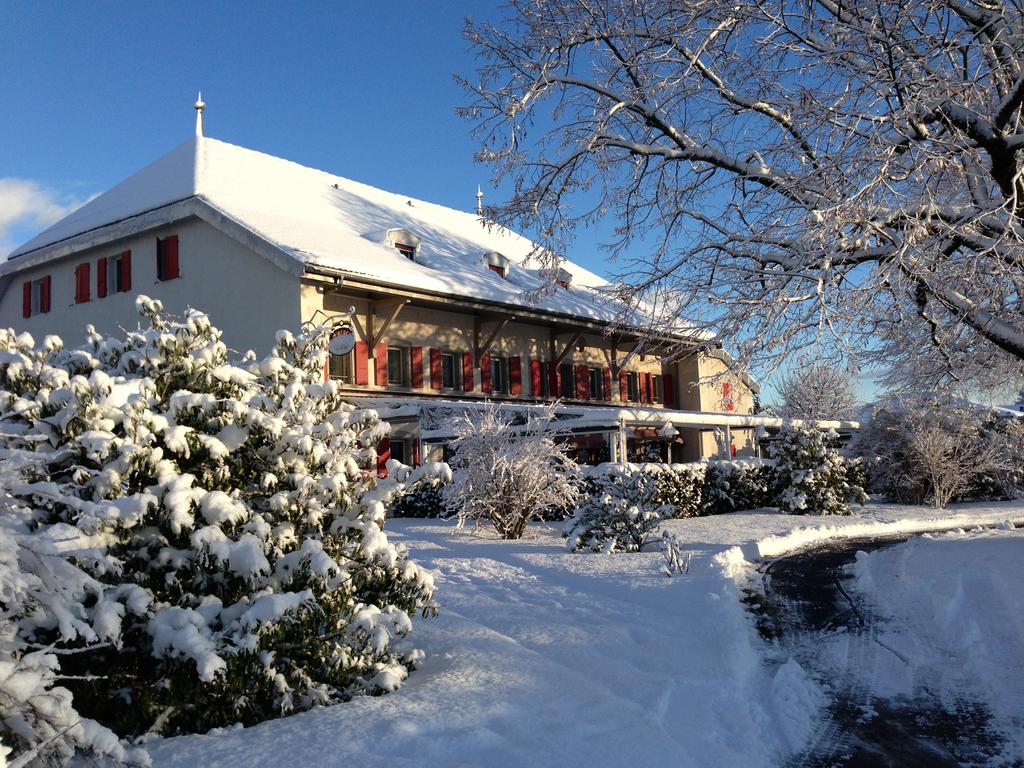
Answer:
[854,529,1024,760]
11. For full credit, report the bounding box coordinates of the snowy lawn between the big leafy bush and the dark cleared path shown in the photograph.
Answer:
[148,503,1024,768]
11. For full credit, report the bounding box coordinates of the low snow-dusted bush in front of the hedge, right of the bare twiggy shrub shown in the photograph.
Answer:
[562,464,675,553]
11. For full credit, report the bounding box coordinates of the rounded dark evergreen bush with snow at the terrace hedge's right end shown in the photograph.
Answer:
[770,427,867,515]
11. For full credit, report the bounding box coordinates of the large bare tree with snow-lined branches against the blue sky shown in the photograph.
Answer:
[462,0,1024,386]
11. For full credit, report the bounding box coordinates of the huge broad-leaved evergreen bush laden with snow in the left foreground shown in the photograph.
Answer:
[0,297,433,757]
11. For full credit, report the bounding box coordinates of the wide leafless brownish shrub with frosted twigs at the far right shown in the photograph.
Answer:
[852,397,1024,508]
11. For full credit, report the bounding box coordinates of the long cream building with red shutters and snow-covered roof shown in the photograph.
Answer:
[0,102,847,462]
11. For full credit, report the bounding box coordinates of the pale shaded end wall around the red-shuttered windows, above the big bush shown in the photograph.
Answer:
[0,219,301,355]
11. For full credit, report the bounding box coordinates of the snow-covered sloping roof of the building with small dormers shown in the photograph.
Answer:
[6,136,679,329]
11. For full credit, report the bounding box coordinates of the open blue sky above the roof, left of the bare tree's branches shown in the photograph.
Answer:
[0,0,880,401]
